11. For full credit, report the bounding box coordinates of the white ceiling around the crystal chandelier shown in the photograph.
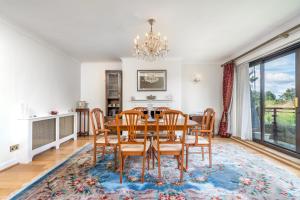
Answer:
[0,0,300,63]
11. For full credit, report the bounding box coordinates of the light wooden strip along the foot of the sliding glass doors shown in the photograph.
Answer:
[231,137,300,170]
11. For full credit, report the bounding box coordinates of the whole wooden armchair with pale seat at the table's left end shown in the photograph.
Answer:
[90,108,118,169]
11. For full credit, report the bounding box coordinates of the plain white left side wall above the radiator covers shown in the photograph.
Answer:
[0,20,80,169]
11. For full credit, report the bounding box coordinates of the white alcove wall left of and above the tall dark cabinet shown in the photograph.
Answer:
[81,62,122,112]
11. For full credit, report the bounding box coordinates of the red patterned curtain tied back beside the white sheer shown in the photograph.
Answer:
[219,62,234,137]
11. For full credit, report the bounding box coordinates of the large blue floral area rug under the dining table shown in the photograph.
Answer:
[12,144,300,200]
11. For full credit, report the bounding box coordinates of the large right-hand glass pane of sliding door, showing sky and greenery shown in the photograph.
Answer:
[264,52,296,151]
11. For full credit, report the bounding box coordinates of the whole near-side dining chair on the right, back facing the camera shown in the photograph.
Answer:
[152,110,188,182]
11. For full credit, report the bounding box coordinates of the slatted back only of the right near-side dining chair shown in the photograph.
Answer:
[156,109,188,144]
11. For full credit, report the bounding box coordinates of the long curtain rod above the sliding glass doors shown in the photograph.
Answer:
[221,24,300,67]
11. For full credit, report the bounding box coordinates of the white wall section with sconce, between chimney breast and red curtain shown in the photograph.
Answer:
[182,64,223,131]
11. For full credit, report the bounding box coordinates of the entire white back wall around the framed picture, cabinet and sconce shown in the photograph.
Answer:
[81,58,223,131]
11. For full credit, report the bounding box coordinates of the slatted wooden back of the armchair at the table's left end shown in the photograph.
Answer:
[90,108,107,143]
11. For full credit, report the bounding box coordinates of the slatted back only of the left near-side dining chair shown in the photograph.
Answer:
[116,110,148,144]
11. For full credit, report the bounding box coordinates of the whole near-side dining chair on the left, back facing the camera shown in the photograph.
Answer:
[116,110,150,183]
